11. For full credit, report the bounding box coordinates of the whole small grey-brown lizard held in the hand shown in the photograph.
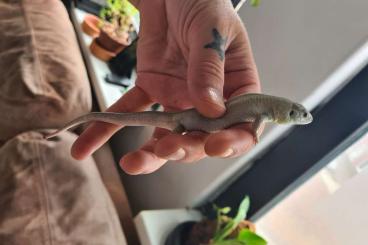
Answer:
[45,94,313,143]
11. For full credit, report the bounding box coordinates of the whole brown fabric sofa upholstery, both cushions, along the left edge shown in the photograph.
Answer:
[0,0,126,245]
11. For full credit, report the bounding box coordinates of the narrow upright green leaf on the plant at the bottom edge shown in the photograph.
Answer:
[213,196,250,242]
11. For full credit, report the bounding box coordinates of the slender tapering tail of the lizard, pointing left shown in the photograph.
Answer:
[44,111,176,139]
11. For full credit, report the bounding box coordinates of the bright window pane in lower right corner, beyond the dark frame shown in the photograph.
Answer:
[257,129,368,245]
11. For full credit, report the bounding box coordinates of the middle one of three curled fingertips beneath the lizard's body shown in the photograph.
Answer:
[155,132,208,162]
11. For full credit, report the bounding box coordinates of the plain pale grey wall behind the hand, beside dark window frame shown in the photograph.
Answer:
[119,0,368,210]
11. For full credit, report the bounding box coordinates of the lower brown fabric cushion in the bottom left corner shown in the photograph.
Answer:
[0,132,126,245]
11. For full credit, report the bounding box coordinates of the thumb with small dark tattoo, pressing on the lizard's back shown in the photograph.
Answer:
[187,5,239,118]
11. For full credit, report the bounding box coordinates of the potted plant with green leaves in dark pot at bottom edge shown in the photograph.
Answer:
[165,197,267,245]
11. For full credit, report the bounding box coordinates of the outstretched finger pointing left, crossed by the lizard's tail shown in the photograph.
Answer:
[71,87,152,160]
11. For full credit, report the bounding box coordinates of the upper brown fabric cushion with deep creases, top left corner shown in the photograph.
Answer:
[0,0,91,141]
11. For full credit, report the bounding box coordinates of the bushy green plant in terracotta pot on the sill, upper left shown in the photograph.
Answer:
[90,0,137,61]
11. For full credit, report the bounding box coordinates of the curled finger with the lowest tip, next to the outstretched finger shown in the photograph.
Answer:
[120,128,169,175]
